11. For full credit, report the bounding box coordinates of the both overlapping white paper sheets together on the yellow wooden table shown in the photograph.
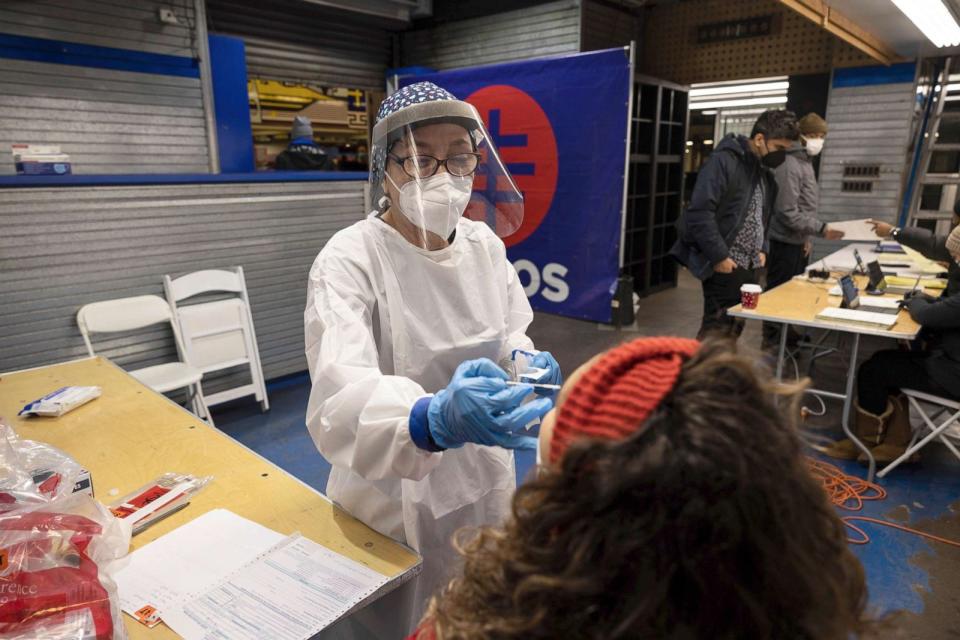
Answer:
[115,509,389,640]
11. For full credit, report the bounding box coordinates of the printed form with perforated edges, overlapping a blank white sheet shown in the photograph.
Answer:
[163,535,389,640]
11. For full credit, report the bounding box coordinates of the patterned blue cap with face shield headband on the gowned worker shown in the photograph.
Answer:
[370,82,482,209]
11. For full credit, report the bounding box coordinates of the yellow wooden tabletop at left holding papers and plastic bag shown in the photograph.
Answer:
[0,357,420,639]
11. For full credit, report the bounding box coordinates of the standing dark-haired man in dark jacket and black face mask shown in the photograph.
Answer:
[670,109,800,339]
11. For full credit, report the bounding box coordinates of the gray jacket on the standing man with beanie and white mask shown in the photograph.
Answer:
[769,142,826,244]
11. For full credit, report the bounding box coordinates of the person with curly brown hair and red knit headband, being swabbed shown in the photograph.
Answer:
[412,338,869,640]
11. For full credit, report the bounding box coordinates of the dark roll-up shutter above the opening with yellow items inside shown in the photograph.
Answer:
[207,0,396,90]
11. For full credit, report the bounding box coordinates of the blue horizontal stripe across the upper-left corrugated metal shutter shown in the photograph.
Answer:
[0,33,200,78]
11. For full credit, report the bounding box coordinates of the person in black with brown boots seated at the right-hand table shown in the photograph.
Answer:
[825,227,960,464]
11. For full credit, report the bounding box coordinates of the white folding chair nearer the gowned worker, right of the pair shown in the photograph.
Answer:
[163,267,270,411]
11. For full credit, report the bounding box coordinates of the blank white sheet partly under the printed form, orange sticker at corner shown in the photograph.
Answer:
[114,509,285,618]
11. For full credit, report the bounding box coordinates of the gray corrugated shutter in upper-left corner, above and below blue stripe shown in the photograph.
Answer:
[0,0,209,174]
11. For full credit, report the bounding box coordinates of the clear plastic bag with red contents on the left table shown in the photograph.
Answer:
[0,424,130,640]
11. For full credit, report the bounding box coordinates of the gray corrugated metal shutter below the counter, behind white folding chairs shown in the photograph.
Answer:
[0,181,366,380]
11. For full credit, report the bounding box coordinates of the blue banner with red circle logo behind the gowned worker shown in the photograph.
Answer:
[400,49,631,322]
